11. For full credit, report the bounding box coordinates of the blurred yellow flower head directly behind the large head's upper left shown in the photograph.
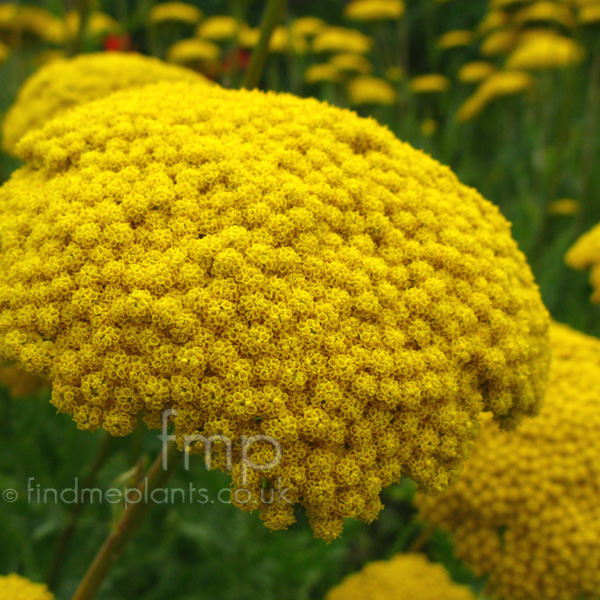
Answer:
[2,52,204,153]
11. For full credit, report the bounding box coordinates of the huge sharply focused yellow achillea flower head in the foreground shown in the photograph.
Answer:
[0,82,549,540]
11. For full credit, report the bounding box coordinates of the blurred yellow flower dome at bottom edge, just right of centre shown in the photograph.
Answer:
[325,554,475,600]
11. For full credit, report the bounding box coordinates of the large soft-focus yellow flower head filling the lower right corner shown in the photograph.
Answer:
[417,324,600,600]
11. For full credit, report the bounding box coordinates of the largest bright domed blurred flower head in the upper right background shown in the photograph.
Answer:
[506,34,584,71]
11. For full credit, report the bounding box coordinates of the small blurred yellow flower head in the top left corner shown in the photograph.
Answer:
[0,3,65,44]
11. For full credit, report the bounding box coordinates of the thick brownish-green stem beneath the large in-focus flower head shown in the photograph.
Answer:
[72,442,177,600]
